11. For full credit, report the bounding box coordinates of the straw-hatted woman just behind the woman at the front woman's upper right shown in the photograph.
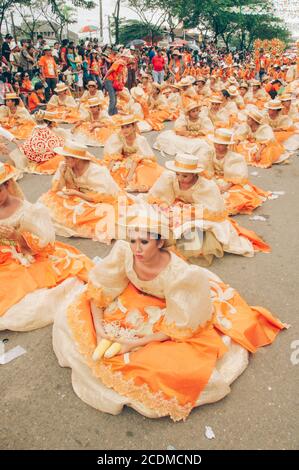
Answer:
[206,129,270,215]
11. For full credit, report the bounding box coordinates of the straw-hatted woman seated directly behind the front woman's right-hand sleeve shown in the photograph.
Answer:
[146,154,270,265]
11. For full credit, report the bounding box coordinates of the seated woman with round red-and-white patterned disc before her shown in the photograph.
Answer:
[9,110,64,175]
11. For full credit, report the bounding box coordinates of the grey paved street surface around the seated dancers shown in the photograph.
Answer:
[0,126,299,449]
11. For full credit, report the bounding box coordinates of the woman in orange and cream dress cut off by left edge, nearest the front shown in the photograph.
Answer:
[0,163,92,331]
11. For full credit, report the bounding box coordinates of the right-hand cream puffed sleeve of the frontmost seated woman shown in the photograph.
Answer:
[158,259,212,339]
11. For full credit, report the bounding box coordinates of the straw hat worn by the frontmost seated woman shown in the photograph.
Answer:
[118,205,172,245]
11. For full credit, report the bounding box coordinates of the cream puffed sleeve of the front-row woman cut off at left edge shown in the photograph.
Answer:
[19,203,55,253]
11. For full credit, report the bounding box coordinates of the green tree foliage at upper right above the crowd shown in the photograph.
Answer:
[128,0,289,49]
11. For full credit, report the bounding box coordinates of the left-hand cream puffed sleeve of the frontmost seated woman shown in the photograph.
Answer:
[87,240,130,308]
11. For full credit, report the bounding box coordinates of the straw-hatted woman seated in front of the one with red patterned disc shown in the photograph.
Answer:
[40,141,128,244]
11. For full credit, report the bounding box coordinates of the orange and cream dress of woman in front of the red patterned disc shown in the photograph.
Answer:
[40,161,127,243]
